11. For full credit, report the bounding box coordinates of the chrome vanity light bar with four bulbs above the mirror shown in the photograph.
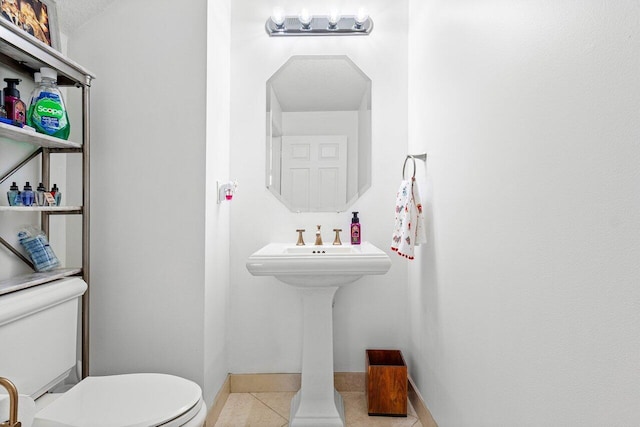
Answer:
[265,8,373,36]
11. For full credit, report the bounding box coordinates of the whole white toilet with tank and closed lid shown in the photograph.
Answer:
[0,278,207,427]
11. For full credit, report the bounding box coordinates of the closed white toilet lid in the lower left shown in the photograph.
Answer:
[35,374,202,427]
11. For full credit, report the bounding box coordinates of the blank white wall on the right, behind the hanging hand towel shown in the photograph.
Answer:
[410,0,640,427]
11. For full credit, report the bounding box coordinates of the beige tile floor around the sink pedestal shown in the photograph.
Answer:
[215,391,422,427]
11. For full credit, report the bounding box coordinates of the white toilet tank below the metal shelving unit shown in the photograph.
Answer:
[0,277,87,398]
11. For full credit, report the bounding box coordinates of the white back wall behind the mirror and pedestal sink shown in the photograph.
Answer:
[228,0,408,373]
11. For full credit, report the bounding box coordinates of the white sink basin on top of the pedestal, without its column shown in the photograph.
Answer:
[247,242,391,287]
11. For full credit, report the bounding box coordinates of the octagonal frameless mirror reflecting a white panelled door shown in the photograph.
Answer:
[266,55,371,212]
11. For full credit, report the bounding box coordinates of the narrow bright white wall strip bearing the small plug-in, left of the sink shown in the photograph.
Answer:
[204,0,231,403]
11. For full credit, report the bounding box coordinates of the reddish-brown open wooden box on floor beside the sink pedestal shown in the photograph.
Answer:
[365,350,408,417]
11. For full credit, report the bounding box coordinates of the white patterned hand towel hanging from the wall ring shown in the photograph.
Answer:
[391,178,427,259]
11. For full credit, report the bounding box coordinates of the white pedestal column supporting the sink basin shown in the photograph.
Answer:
[289,286,345,427]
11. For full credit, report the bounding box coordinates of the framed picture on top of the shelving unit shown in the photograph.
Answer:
[0,0,60,51]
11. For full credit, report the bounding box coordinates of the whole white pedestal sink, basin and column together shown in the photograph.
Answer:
[247,242,391,427]
